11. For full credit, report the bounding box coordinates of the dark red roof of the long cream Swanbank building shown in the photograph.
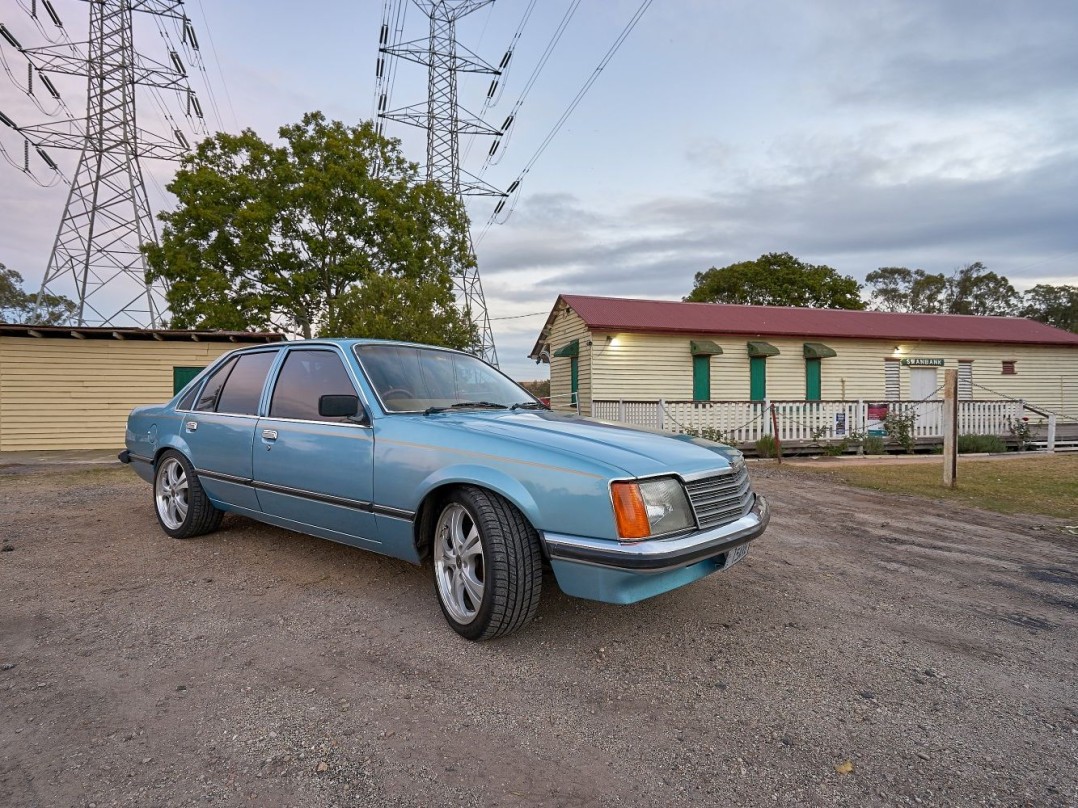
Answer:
[547,294,1078,346]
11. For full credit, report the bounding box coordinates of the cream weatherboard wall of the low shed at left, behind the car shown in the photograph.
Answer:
[0,336,241,451]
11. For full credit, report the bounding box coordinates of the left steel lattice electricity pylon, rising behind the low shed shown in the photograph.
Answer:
[2,0,203,328]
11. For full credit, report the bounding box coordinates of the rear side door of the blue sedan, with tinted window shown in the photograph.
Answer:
[181,350,278,512]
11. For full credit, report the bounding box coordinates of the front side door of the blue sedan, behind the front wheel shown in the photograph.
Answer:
[253,346,379,548]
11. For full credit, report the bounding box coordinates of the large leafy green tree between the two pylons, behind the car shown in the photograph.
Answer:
[142,112,470,345]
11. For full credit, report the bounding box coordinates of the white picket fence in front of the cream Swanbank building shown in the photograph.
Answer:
[592,400,1024,450]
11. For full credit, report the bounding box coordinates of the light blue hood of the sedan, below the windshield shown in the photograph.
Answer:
[426,410,741,477]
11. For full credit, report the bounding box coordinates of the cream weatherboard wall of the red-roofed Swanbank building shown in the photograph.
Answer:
[550,310,1078,417]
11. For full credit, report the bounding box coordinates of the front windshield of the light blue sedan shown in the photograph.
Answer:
[356,345,541,414]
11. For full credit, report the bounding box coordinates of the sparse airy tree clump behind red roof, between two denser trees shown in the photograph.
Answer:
[865,261,1020,315]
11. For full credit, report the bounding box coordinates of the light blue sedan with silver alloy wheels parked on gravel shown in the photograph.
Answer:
[120,339,769,640]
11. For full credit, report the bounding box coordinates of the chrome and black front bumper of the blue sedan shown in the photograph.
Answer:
[543,494,771,574]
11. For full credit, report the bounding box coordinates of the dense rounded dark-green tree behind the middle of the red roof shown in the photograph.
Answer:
[685,252,865,309]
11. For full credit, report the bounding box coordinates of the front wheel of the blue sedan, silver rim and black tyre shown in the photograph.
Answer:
[432,486,542,641]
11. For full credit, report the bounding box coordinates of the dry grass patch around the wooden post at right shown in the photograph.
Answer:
[787,455,1078,524]
